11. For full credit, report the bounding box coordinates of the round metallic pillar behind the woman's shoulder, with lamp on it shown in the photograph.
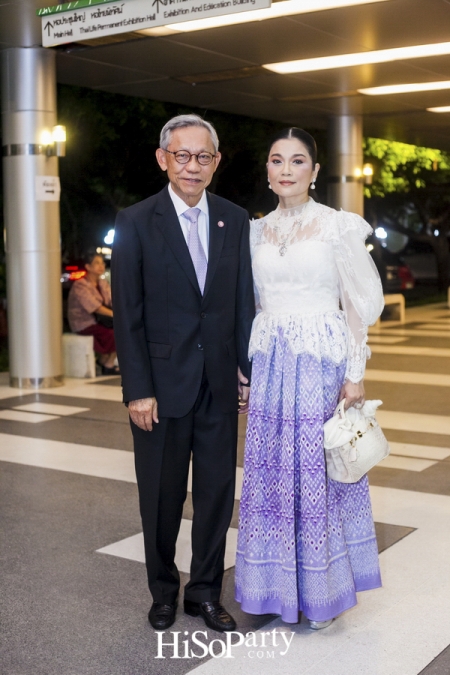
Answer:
[328,115,364,216]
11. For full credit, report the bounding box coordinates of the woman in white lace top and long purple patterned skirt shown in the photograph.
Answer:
[236,127,383,629]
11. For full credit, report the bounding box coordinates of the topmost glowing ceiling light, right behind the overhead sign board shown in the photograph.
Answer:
[139,0,389,35]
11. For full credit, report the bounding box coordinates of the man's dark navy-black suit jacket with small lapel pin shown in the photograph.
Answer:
[111,187,255,417]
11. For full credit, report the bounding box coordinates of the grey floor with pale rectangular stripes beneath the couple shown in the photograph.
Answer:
[0,305,450,675]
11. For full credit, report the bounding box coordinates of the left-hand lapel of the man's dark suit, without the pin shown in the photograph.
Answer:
[155,187,200,295]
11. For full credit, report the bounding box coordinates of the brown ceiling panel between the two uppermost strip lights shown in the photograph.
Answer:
[163,0,450,64]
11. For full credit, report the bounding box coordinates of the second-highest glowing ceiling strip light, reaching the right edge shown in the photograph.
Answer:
[263,42,450,74]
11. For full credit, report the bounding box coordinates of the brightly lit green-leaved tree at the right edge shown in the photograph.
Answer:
[364,138,450,290]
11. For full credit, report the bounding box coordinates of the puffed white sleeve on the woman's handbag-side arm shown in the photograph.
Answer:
[335,211,384,382]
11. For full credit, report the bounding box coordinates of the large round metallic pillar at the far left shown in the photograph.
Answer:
[2,45,63,389]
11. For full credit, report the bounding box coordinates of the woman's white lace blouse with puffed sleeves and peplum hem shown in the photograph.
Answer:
[249,198,384,382]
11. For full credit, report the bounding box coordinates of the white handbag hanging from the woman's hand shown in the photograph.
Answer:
[324,399,389,483]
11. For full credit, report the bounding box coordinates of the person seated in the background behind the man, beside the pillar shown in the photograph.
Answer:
[67,252,120,375]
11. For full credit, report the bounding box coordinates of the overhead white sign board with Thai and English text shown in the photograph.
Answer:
[38,0,271,47]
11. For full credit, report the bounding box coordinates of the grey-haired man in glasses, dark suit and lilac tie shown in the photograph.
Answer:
[112,115,255,631]
